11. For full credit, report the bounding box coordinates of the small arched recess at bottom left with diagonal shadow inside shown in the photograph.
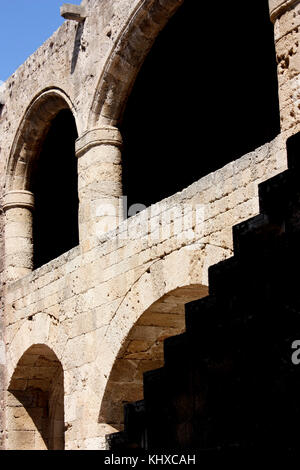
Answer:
[7,344,64,450]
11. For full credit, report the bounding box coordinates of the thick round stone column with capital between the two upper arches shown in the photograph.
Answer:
[76,126,123,251]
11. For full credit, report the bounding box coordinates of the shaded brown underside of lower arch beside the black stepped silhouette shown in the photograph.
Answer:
[99,284,208,431]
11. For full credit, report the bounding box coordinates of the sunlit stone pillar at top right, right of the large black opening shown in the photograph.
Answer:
[269,0,300,137]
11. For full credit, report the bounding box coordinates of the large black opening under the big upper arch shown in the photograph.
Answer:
[121,0,280,211]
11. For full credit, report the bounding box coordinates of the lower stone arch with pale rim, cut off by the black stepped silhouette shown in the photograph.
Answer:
[98,245,231,433]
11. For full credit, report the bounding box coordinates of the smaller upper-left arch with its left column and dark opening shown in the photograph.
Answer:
[3,89,78,282]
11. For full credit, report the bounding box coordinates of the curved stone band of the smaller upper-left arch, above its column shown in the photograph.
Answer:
[5,88,76,193]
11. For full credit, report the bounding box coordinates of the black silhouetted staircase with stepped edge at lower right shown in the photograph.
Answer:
[107,135,300,451]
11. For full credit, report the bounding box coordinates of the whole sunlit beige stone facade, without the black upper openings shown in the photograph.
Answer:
[0,0,300,449]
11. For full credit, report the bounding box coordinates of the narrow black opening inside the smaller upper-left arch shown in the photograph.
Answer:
[30,109,79,269]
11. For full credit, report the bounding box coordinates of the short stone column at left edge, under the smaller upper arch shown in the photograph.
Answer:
[3,191,34,282]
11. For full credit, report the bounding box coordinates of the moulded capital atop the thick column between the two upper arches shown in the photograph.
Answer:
[75,126,123,158]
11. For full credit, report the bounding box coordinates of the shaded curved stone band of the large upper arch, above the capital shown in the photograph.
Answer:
[89,0,184,127]
